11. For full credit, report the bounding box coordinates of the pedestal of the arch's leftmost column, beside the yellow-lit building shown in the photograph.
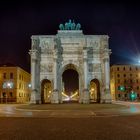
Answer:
[29,89,41,104]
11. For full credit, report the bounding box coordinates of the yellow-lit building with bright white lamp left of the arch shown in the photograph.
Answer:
[0,65,31,103]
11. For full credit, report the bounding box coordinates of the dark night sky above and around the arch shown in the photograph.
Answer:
[0,1,140,71]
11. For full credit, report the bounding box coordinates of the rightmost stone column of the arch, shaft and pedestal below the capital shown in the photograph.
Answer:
[104,58,111,103]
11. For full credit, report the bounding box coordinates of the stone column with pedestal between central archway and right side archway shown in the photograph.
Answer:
[83,50,90,104]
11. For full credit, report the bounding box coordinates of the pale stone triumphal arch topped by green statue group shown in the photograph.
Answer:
[29,20,111,104]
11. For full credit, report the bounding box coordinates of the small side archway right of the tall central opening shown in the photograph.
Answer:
[90,79,100,103]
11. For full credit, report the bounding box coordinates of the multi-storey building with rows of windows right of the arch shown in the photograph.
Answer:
[110,65,140,101]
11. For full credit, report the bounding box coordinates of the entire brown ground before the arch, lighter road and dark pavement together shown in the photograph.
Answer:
[0,102,140,140]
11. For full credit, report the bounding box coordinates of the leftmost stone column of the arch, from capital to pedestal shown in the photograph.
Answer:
[29,50,41,104]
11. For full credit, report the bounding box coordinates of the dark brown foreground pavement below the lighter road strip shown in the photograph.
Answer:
[0,116,140,140]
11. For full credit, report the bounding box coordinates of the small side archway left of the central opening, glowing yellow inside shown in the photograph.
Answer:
[41,79,52,104]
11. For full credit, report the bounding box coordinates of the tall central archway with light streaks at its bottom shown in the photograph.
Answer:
[62,64,79,102]
